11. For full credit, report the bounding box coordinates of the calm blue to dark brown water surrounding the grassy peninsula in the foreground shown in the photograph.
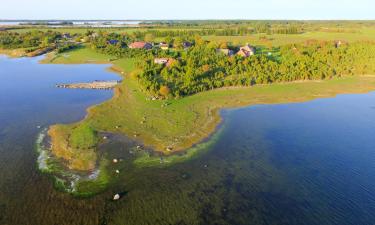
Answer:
[0,57,375,225]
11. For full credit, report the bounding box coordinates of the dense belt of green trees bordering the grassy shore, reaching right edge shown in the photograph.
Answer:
[137,42,375,97]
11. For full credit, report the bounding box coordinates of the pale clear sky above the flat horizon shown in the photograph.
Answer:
[0,0,375,20]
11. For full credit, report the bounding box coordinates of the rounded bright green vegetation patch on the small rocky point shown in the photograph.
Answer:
[69,124,98,149]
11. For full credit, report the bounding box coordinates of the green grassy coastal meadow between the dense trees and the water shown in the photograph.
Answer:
[44,48,375,171]
